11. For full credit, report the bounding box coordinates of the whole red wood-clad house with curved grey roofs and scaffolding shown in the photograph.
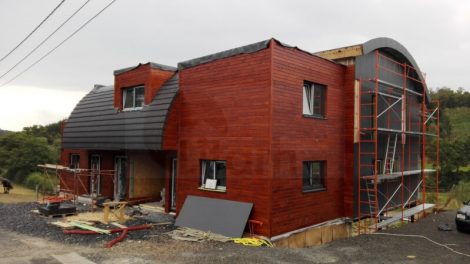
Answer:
[61,38,438,237]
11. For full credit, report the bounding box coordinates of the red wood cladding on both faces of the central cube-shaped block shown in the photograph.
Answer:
[177,41,345,236]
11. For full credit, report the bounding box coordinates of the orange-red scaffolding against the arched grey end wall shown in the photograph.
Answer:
[355,50,440,234]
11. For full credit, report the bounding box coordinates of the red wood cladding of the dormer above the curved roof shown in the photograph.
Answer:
[114,64,175,109]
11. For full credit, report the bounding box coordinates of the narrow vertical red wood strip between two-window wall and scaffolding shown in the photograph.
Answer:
[343,65,355,217]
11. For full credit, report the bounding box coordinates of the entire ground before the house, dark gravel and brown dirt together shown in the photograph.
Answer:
[0,204,470,264]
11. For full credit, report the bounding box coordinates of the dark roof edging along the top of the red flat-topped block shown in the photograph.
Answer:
[178,38,338,70]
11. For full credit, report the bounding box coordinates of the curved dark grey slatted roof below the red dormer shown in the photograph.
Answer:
[62,74,179,150]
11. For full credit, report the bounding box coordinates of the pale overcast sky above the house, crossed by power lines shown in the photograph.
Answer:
[0,0,470,130]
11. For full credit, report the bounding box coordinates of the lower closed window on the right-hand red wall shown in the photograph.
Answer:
[302,161,325,192]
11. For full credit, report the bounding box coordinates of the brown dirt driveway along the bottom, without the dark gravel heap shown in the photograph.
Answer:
[0,205,470,264]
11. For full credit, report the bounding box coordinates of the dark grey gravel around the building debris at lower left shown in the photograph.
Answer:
[0,203,175,246]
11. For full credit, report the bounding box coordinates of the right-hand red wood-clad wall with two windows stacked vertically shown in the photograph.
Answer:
[270,41,345,236]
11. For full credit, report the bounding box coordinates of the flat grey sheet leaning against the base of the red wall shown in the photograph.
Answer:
[175,195,253,237]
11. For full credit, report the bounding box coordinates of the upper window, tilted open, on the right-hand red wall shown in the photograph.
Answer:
[303,82,326,117]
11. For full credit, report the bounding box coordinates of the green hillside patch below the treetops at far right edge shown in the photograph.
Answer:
[444,107,470,139]
